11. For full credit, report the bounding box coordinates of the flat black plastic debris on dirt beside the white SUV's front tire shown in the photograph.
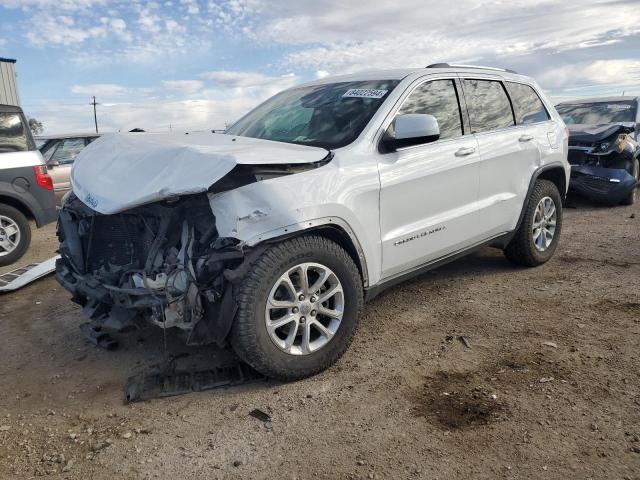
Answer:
[124,362,266,404]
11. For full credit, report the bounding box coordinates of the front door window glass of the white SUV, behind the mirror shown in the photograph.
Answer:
[396,80,462,140]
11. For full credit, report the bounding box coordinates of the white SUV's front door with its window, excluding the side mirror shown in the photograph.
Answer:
[378,78,480,279]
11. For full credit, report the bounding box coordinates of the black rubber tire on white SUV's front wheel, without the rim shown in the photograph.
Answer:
[230,235,363,381]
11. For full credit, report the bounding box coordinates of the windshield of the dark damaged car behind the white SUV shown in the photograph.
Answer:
[556,102,636,125]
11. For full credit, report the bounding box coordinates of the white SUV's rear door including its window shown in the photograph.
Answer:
[462,78,548,238]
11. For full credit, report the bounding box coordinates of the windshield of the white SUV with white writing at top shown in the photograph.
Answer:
[226,80,398,149]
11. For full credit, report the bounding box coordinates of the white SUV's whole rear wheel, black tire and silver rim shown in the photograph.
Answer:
[504,180,562,267]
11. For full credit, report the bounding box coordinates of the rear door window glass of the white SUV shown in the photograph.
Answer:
[462,79,514,133]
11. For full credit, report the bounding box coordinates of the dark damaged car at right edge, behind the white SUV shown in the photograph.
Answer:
[556,97,640,205]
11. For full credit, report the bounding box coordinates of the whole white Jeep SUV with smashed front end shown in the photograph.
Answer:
[57,64,570,380]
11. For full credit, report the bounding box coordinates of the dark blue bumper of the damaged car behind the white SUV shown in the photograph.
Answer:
[569,165,637,203]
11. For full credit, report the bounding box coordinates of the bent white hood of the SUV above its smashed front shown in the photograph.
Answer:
[71,132,328,214]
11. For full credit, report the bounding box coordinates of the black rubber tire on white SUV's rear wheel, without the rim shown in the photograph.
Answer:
[504,180,562,267]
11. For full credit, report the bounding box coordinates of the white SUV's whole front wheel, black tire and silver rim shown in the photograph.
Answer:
[230,236,363,380]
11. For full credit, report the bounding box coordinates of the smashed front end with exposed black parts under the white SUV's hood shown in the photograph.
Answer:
[56,194,245,344]
